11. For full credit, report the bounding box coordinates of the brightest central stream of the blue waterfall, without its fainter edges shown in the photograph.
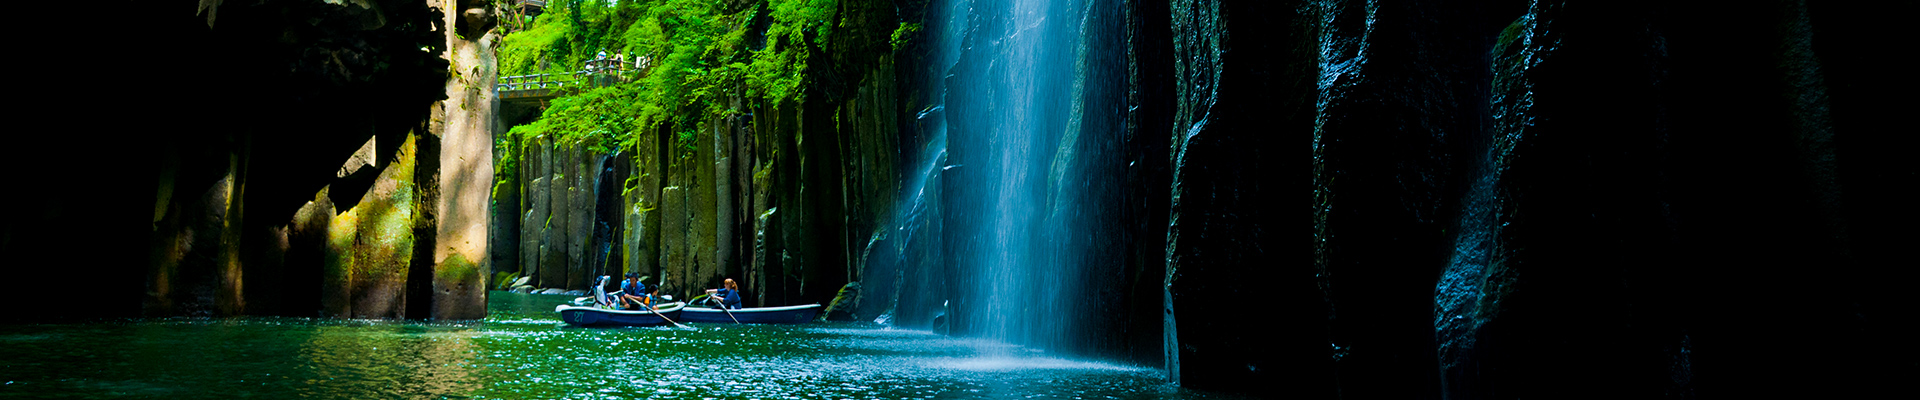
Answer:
[947,0,1071,344]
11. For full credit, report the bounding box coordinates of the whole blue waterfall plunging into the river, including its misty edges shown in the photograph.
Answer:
[935,0,1125,350]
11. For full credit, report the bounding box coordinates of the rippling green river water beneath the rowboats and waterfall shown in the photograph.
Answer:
[0,292,1219,400]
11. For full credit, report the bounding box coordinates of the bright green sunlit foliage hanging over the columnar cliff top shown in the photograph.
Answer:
[499,0,844,171]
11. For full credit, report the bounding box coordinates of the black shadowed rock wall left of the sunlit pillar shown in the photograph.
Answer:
[0,0,480,319]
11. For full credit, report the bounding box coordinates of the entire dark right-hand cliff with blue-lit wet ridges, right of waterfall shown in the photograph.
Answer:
[1175,2,1912,398]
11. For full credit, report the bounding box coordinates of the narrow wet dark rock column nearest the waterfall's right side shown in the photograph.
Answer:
[1140,2,1332,396]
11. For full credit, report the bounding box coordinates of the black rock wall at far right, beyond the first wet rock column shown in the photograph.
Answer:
[1297,2,1912,398]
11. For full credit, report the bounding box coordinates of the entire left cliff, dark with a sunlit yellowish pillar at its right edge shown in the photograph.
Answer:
[0,0,493,319]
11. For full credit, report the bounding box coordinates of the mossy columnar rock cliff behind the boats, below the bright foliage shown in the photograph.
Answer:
[493,2,900,309]
